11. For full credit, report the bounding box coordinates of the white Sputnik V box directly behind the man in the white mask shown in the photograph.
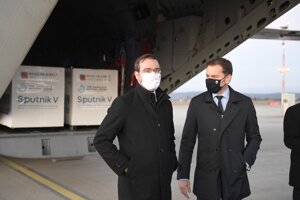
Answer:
[65,68,118,126]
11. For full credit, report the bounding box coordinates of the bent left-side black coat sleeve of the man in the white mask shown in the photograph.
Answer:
[94,97,128,175]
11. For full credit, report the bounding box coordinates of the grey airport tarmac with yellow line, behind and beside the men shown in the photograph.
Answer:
[0,102,292,200]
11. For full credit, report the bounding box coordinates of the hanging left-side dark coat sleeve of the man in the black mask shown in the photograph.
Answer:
[177,102,198,179]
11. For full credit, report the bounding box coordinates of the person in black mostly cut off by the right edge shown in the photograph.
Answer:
[283,103,300,200]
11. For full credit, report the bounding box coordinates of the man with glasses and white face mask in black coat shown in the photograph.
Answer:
[94,54,177,200]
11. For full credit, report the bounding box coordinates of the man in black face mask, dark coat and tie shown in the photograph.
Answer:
[177,58,261,200]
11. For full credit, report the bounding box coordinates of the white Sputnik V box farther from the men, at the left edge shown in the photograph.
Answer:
[0,66,65,128]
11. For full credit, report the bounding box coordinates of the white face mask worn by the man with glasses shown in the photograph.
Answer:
[140,72,161,91]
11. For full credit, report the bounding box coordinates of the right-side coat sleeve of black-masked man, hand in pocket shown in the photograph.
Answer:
[244,100,262,166]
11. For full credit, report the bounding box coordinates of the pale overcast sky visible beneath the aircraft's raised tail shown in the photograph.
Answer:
[175,5,300,93]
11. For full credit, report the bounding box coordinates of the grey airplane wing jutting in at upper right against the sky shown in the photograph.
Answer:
[252,28,300,40]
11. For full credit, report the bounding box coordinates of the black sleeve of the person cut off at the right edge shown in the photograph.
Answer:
[283,107,300,153]
